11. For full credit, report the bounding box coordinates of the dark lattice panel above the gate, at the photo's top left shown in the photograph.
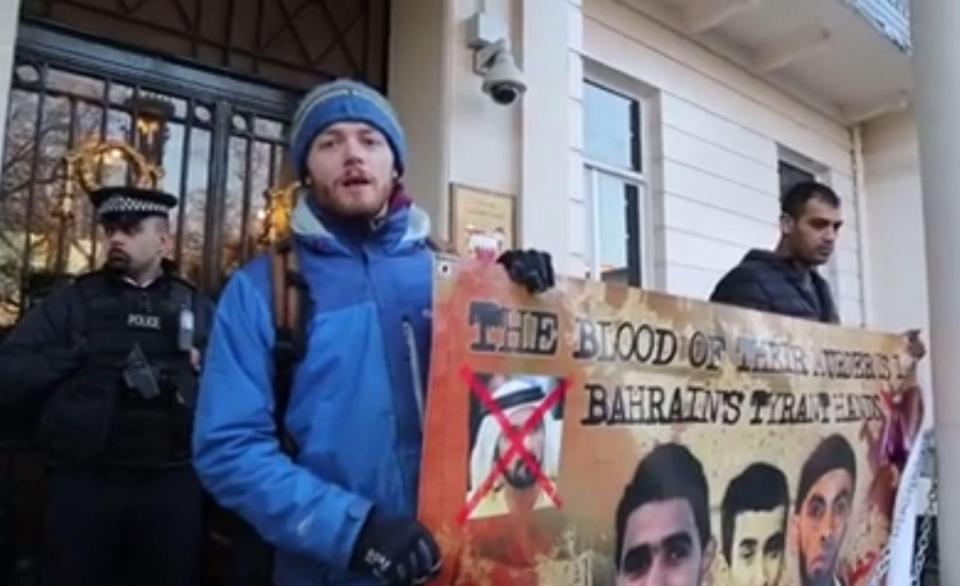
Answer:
[23,0,389,88]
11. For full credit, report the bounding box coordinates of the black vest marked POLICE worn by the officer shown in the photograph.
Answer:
[78,273,197,466]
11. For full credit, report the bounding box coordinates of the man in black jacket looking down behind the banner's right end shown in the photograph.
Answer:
[710,181,926,360]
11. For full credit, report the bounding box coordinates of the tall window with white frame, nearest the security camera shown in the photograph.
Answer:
[583,80,648,286]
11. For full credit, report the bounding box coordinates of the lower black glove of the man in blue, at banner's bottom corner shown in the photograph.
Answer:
[350,508,442,586]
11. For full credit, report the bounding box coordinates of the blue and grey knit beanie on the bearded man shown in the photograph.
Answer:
[290,79,407,179]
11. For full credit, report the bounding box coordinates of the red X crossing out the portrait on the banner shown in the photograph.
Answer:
[457,366,569,524]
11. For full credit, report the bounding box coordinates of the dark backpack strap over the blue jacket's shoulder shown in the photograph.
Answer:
[270,240,308,456]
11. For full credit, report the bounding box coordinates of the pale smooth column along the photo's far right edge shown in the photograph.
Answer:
[913,0,960,584]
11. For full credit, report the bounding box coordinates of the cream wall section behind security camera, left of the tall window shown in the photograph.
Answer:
[389,0,581,262]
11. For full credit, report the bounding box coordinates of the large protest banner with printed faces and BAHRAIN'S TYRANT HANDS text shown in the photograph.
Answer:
[419,260,923,586]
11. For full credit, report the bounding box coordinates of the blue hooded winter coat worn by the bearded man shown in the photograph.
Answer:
[194,194,432,586]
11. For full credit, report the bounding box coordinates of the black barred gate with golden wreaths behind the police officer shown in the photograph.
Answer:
[0,27,296,326]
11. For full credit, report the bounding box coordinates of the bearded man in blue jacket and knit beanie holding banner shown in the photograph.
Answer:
[194,80,553,585]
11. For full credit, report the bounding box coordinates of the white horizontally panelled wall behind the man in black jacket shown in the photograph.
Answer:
[571,0,863,325]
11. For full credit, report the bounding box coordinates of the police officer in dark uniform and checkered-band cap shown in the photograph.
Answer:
[0,187,212,586]
